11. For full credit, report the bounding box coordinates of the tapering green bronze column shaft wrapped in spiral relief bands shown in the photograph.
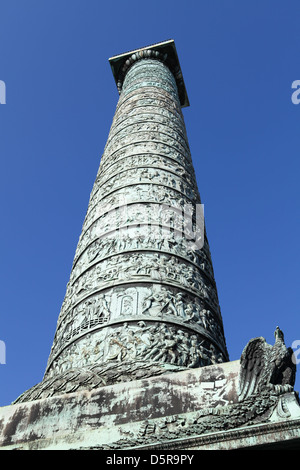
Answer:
[41,56,228,383]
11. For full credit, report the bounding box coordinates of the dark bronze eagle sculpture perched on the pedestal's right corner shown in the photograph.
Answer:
[238,326,296,401]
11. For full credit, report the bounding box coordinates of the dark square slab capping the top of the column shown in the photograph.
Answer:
[109,39,190,108]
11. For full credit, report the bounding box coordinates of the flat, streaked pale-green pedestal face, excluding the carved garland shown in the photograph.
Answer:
[0,362,239,448]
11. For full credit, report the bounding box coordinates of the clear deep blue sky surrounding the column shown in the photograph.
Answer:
[0,0,300,406]
